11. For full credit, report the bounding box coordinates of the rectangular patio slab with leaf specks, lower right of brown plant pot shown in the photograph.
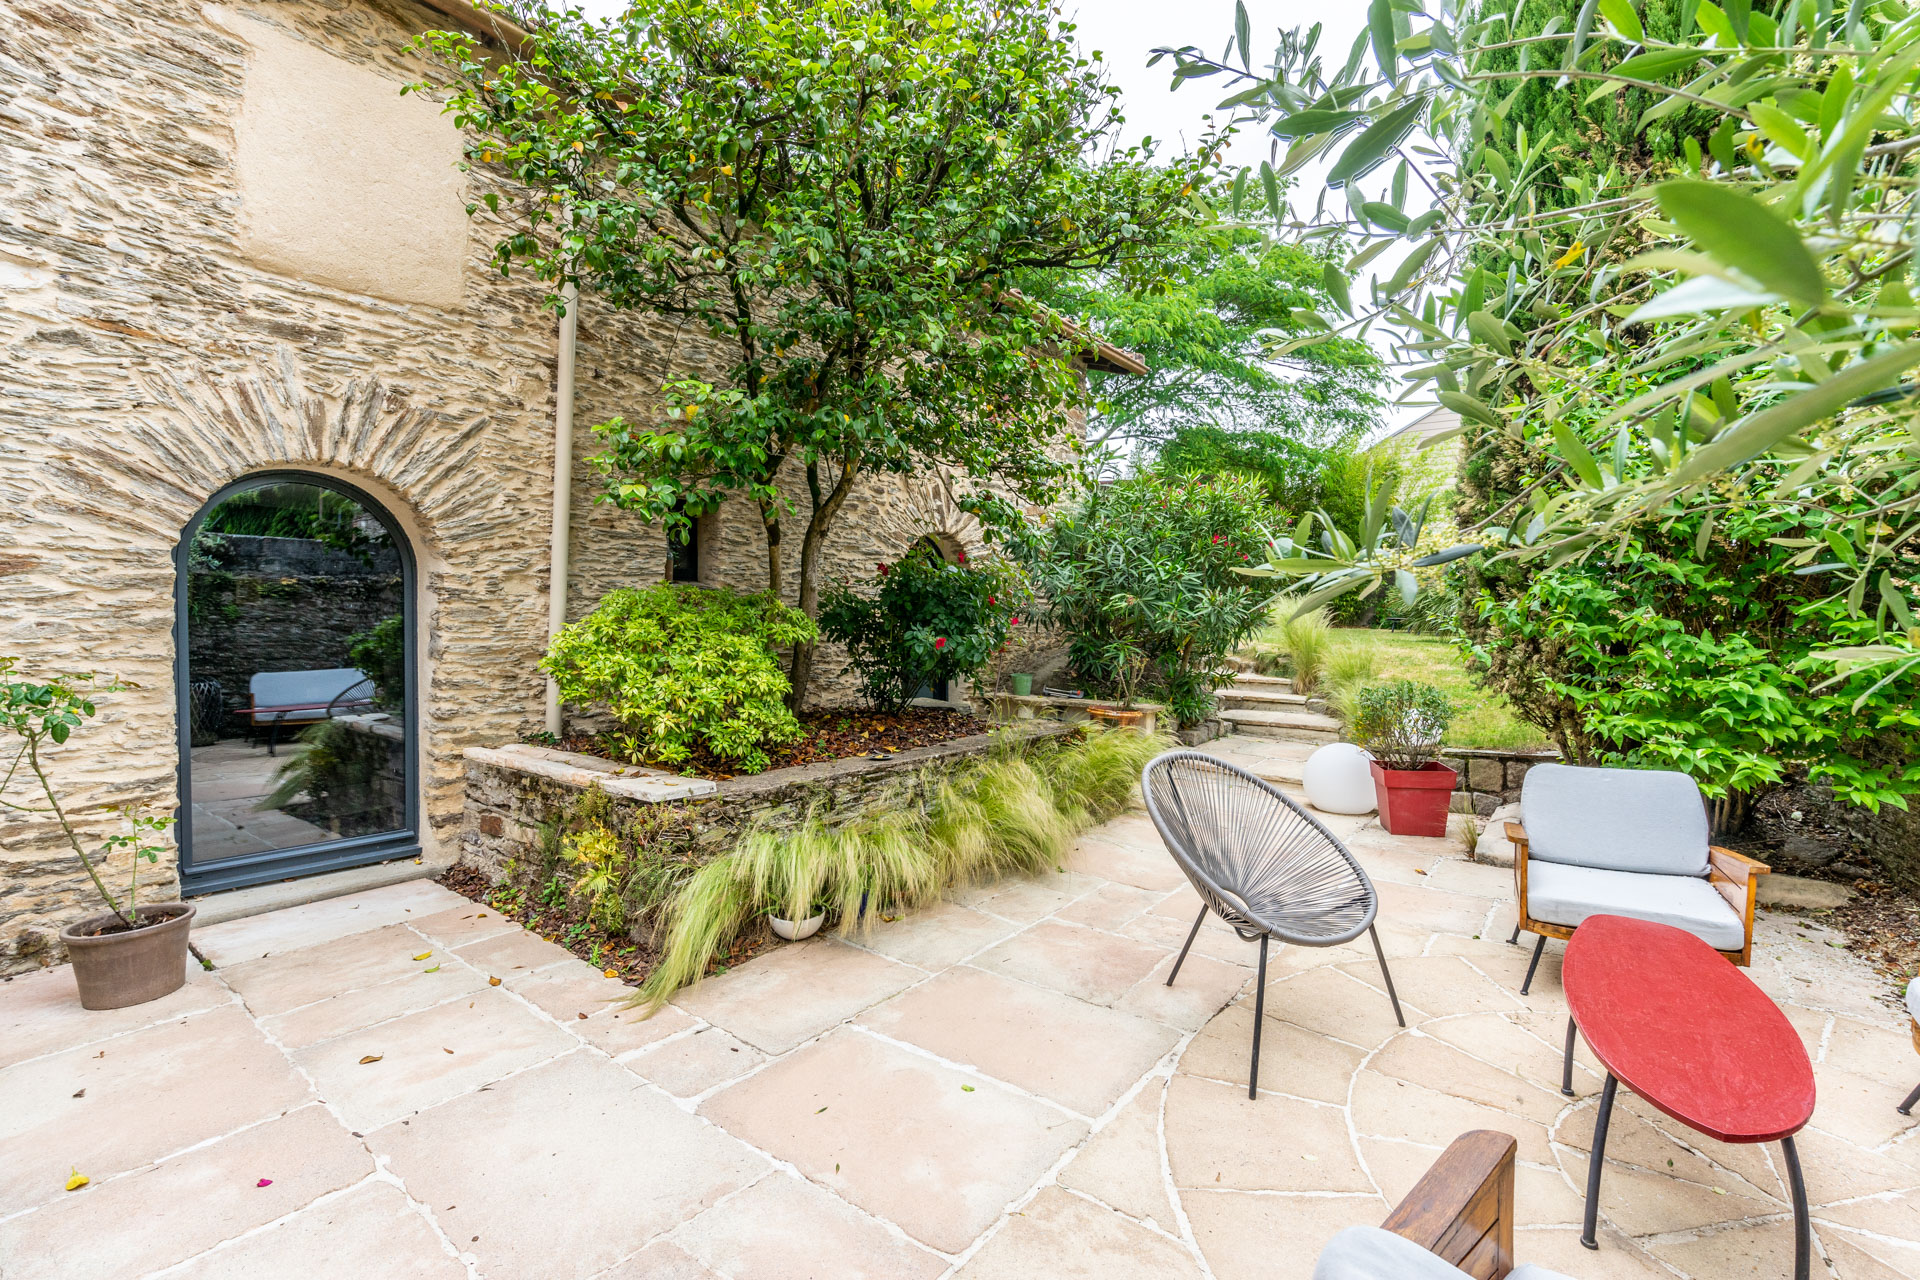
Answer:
[294,990,578,1132]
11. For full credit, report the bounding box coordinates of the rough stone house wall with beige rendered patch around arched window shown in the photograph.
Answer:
[0,0,1090,973]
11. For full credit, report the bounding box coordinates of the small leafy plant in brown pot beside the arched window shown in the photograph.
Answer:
[0,658,194,1009]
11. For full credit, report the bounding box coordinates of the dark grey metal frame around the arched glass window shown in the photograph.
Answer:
[173,468,420,896]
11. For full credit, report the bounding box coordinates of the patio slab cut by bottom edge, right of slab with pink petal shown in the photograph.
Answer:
[167,1182,467,1280]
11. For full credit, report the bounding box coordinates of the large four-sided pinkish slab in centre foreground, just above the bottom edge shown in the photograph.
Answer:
[701,1031,1087,1253]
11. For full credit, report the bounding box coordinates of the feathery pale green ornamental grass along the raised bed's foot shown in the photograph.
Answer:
[634,729,1169,1009]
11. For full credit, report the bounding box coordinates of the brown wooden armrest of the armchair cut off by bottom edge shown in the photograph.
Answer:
[1380,1128,1517,1280]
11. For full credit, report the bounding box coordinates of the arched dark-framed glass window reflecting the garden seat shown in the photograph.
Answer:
[175,470,420,894]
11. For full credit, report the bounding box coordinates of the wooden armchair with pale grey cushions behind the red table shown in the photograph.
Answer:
[1507,764,1770,996]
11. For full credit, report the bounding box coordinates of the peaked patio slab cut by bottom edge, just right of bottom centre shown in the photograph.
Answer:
[954,1188,1202,1280]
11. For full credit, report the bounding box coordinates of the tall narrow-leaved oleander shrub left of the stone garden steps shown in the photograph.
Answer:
[1008,476,1277,725]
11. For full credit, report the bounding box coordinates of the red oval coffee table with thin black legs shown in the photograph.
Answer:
[1561,915,1812,1280]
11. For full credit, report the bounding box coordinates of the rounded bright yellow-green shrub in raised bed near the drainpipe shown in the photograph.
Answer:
[540,583,816,773]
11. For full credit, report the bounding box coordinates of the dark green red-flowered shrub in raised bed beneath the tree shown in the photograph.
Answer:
[820,545,1033,712]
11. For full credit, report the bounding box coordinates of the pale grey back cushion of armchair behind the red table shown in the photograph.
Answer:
[1521,764,1707,875]
